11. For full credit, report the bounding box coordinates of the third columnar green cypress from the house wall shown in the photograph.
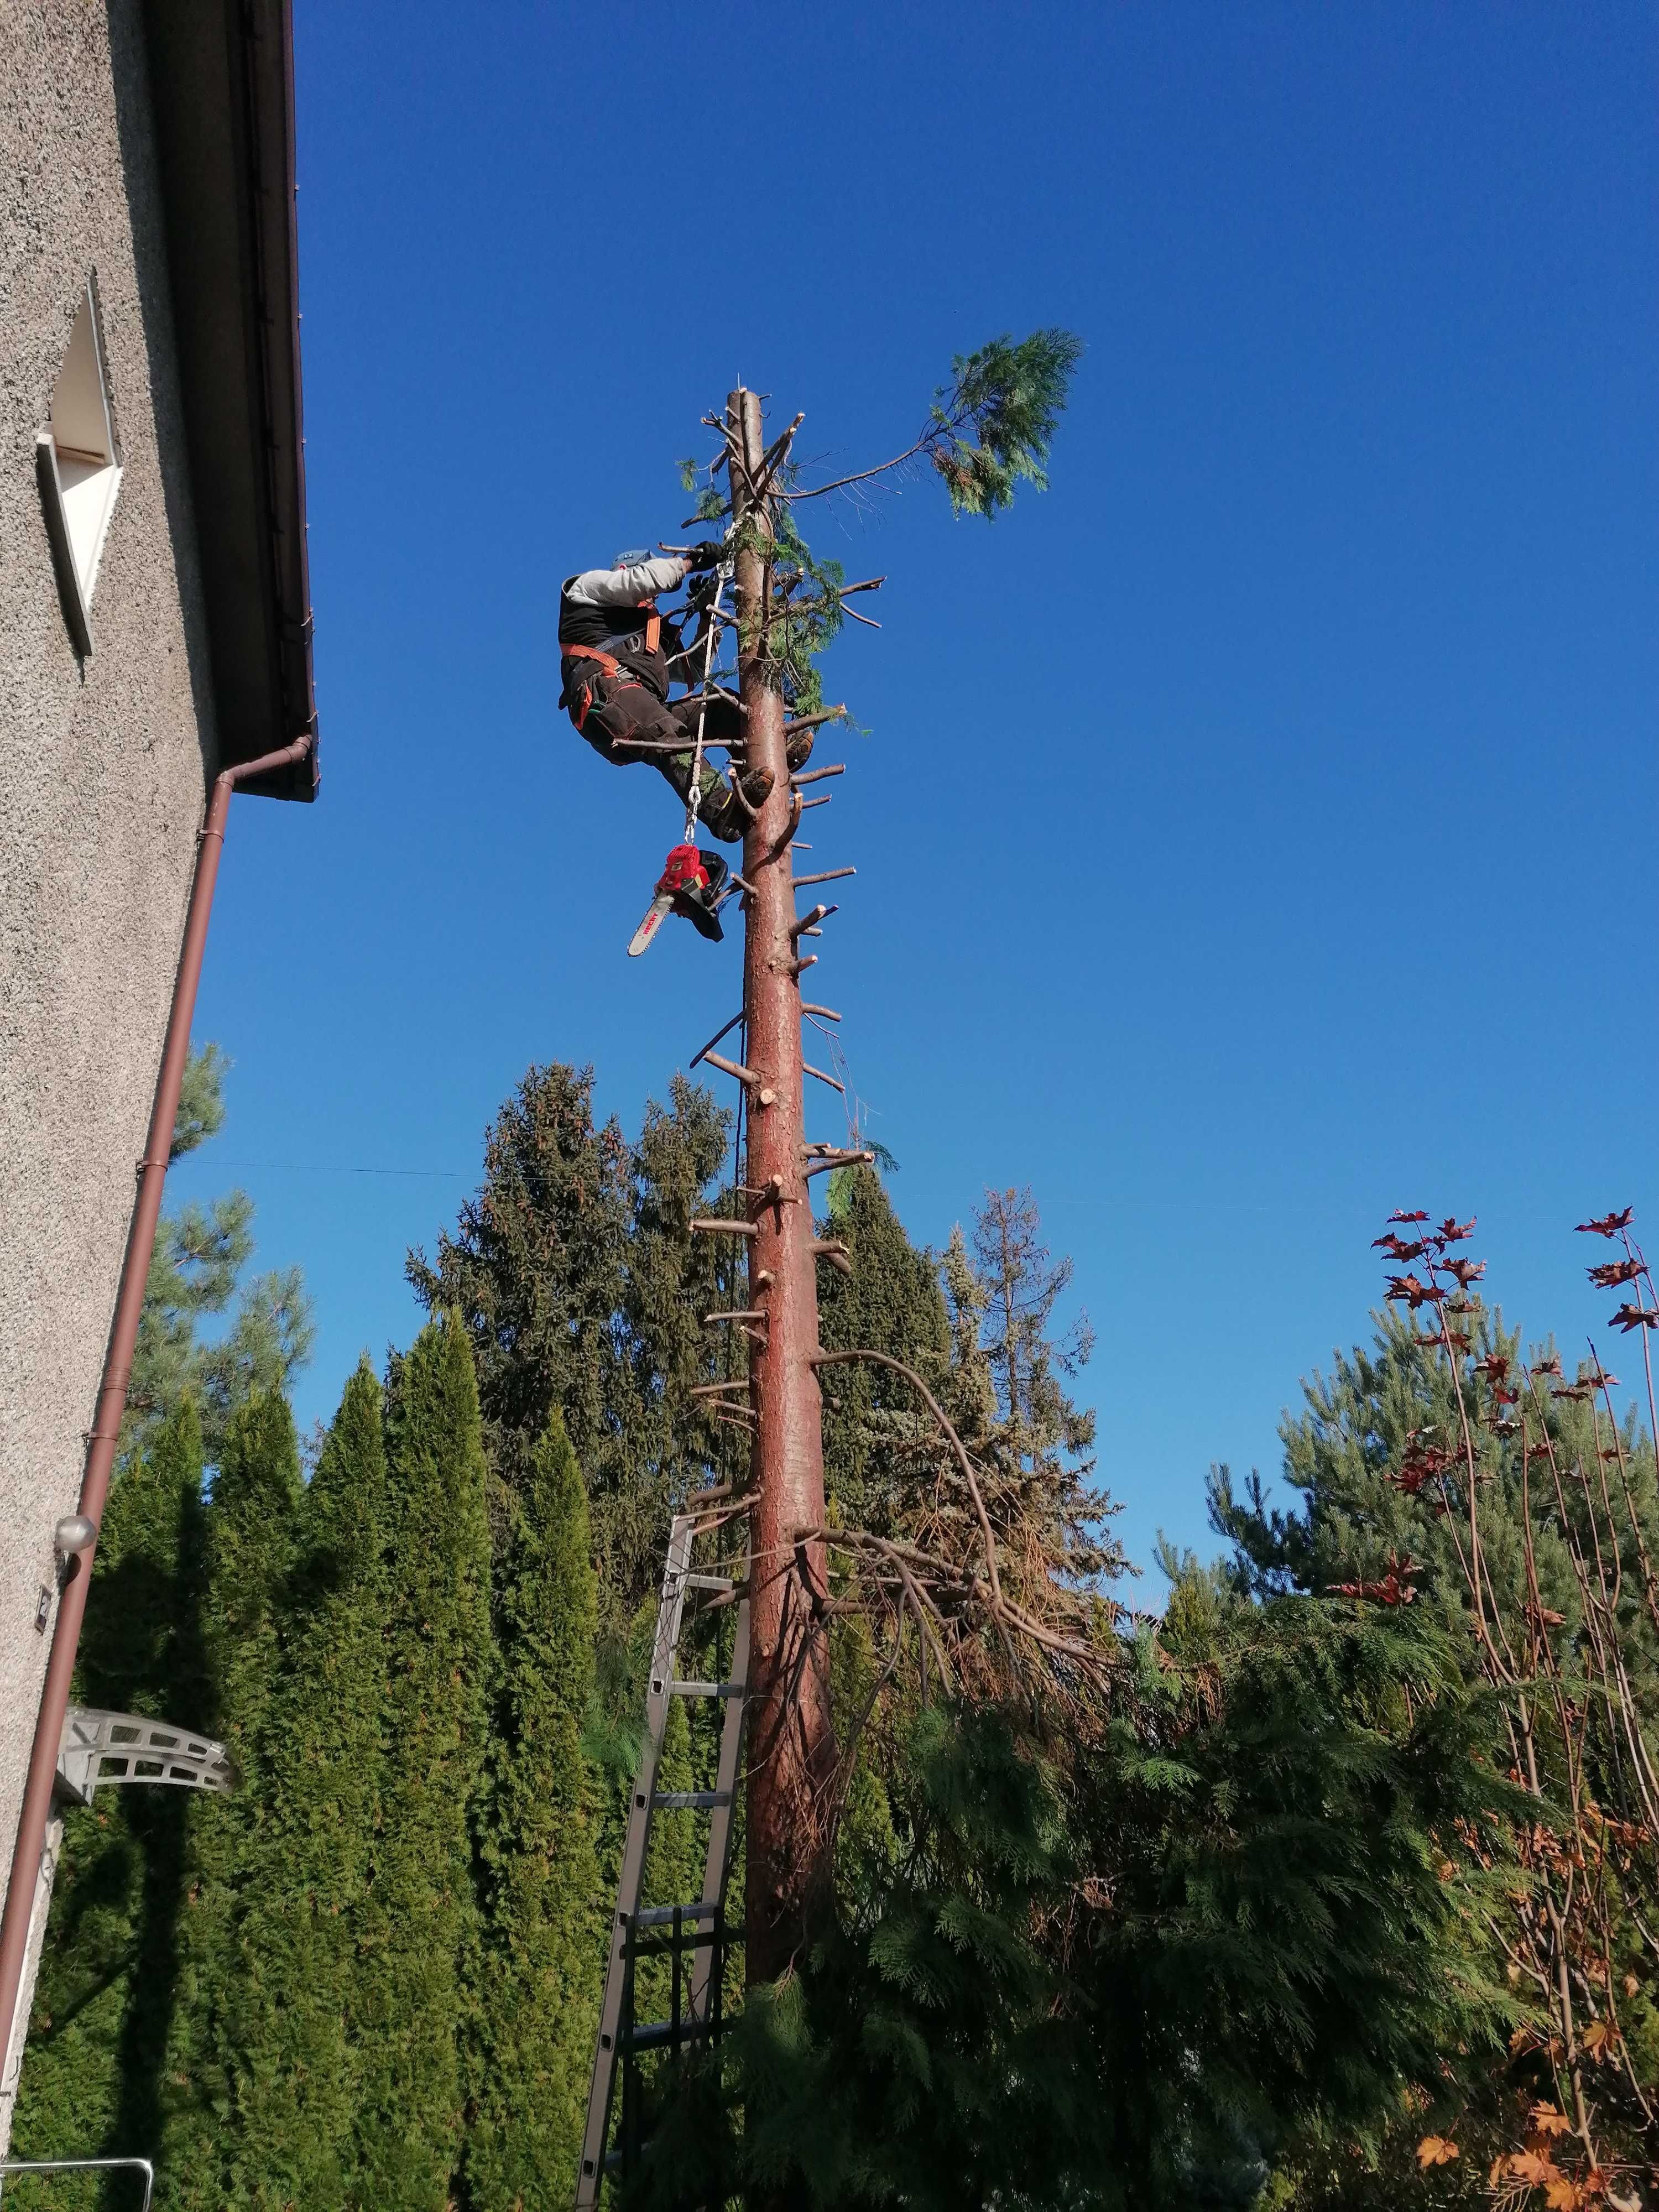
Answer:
[208,1360,387,2212]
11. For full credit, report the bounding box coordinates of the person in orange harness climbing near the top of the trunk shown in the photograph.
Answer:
[560,540,772,845]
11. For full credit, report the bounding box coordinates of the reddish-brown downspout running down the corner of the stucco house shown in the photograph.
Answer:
[0,732,312,2068]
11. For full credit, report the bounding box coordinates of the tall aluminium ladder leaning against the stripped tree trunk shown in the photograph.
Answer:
[575,1491,750,2212]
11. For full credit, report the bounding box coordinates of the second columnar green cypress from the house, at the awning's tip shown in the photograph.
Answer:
[159,1391,301,2212]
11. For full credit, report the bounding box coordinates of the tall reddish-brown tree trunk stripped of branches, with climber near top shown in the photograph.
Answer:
[726,389,834,1982]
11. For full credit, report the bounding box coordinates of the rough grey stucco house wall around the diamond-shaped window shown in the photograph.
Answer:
[0,0,215,2079]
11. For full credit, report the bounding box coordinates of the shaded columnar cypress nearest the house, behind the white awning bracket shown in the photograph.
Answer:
[13,1398,206,2208]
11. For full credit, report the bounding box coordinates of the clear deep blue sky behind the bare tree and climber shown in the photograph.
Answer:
[175,0,1659,1593]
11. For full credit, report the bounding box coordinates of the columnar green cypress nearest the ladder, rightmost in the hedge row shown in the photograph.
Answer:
[462,1411,608,2212]
